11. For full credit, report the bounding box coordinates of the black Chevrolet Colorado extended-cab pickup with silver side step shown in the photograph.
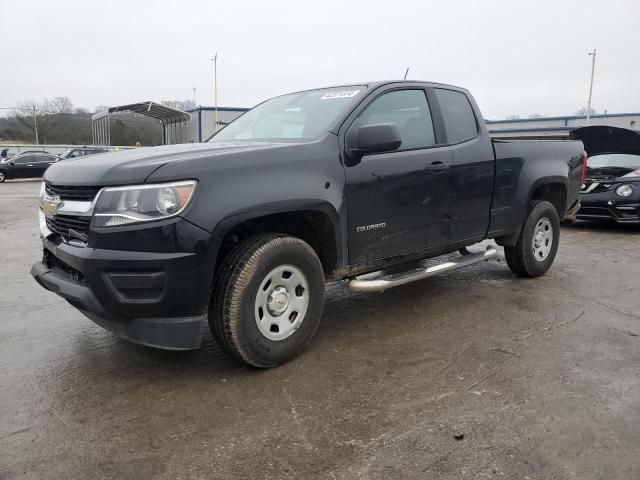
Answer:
[31,81,585,367]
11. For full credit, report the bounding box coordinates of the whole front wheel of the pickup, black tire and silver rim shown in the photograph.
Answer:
[209,234,324,368]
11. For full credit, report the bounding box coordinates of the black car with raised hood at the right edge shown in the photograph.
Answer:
[569,126,640,223]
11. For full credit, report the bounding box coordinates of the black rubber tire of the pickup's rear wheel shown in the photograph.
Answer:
[504,200,560,277]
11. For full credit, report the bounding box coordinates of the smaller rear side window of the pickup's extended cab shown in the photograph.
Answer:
[435,88,478,143]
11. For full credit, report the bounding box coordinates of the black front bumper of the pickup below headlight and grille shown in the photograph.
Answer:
[31,219,218,350]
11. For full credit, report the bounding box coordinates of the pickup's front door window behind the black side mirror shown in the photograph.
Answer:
[359,90,436,150]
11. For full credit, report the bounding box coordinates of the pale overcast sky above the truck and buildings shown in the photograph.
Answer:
[0,0,640,118]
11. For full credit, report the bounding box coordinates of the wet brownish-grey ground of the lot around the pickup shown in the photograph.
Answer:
[0,182,640,480]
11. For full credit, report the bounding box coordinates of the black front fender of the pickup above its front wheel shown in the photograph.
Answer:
[147,134,347,272]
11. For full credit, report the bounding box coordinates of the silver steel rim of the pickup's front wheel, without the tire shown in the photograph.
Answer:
[255,265,309,342]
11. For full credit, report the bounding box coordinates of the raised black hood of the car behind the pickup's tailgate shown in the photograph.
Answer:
[569,125,640,157]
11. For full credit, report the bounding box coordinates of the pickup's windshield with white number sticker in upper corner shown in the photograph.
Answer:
[209,86,365,142]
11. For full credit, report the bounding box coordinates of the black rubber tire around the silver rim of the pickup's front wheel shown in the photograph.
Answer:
[209,234,325,368]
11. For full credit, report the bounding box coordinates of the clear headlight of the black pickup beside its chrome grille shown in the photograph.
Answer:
[92,180,198,227]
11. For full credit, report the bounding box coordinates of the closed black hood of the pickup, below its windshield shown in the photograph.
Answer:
[44,142,278,186]
